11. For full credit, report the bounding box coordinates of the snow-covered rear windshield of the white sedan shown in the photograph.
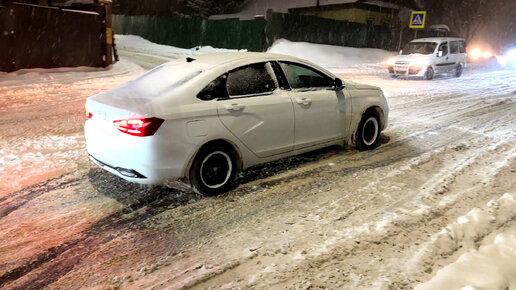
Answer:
[126,61,209,98]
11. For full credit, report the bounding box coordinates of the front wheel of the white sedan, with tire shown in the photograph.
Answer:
[356,111,381,151]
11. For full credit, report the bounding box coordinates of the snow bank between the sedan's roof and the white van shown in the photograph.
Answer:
[268,39,396,68]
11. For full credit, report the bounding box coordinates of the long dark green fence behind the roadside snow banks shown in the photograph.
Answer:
[113,13,399,51]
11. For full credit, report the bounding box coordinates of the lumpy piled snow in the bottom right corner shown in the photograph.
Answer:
[415,193,516,290]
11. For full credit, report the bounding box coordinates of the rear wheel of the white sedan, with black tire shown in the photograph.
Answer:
[190,144,237,196]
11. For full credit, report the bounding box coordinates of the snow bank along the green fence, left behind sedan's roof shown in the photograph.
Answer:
[115,34,246,59]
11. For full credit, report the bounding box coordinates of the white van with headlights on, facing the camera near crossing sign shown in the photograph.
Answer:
[387,37,466,80]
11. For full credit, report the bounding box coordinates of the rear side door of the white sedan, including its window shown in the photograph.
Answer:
[217,62,294,157]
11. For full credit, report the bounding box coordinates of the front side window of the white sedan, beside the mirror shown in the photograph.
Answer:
[280,62,333,89]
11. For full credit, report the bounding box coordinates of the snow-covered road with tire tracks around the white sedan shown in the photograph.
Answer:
[0,37,516,289]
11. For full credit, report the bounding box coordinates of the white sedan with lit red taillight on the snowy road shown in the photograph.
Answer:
[85,52,389,195]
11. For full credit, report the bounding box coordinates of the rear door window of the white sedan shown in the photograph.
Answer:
[227,62,278,97]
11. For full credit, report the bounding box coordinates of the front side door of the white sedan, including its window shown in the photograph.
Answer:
[279,62,347,149]
